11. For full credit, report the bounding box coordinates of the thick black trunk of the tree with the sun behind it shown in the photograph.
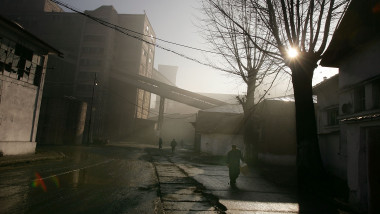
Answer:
[290,60,324,188]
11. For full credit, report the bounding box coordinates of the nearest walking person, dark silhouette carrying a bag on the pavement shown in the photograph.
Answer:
[227,145,243,186]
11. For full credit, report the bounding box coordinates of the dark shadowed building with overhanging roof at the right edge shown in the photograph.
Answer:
[321,0,380,213]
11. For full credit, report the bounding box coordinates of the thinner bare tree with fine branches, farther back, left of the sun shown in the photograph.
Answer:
[202,0,282,162]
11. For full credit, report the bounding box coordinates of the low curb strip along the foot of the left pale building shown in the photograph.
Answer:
[0,152,66,167]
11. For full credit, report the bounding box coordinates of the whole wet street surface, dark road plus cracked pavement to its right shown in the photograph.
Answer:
[0,144,350,214]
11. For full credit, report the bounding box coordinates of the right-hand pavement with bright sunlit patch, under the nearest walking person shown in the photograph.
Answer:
[169,150,350,214]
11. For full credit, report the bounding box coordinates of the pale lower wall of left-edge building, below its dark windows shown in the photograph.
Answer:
[0,75,38,155]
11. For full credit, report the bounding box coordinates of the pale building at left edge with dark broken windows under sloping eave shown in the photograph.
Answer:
[0,17,60,155]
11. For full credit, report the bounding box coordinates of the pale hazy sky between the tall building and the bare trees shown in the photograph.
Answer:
[61,0,336,96]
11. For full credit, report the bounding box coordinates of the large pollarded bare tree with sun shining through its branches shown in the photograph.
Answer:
[207,0,349,182]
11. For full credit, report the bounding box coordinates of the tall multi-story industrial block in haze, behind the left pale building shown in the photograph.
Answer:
[0,0,155,141]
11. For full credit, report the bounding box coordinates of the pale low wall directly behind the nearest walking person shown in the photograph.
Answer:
[201,134,245,155]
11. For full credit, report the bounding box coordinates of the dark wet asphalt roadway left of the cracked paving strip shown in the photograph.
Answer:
[0,146,160,213]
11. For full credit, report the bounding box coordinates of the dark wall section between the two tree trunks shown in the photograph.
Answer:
[254,99,297,165]
